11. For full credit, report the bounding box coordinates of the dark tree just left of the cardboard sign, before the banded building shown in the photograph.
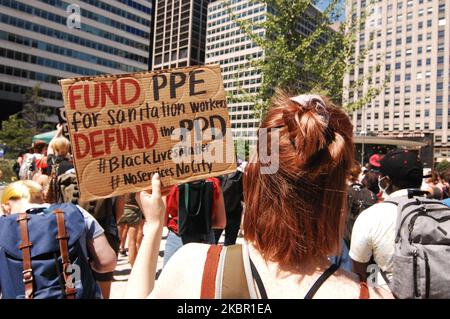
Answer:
[21,84,46,132]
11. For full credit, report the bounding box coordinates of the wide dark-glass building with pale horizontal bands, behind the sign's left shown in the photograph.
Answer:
[0,0,152,122]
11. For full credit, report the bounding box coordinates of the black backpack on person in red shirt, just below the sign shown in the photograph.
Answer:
[178,180,214,245]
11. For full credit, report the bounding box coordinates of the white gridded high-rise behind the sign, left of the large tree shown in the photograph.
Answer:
[206,0,324,145]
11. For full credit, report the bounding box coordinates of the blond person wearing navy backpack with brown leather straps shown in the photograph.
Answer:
[0,181,116,299]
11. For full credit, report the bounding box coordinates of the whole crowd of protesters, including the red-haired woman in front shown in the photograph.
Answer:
[0,92,450,299]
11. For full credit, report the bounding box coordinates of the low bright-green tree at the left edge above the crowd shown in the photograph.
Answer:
[0,114,36,159]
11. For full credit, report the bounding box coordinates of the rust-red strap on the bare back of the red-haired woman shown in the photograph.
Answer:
[200,245,222,299]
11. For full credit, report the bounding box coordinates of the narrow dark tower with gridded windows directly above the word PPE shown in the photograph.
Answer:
[152,0,209,70]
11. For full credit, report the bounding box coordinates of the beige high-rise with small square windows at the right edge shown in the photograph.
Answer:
[344,0,450,160]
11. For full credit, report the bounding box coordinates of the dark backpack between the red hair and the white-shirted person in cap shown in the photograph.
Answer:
[344,183,377,247]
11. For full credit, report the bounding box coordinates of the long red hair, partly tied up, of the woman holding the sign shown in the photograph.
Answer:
[243,93,354,266]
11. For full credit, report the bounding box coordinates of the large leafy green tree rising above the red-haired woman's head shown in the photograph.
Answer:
[226,0,385,117]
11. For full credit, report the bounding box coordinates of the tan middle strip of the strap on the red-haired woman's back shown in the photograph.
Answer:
[221,245,250,299]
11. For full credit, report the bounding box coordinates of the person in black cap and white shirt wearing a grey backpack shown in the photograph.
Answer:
[349,149,423,286]
